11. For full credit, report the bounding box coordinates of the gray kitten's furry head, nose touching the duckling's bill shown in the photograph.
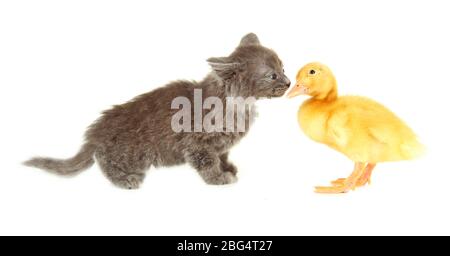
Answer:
[208,34,291,98]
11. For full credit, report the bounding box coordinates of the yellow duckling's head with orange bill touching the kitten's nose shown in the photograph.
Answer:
[287,62,337,100]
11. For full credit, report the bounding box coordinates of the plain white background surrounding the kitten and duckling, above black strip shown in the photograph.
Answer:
[0,0,450,235]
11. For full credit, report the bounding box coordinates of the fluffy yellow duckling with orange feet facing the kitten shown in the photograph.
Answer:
[288,63,423,193]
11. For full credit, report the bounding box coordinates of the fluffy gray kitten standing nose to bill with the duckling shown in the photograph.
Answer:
[25,34,290,189]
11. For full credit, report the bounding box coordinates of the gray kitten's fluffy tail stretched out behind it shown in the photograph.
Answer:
[24,144,95,175]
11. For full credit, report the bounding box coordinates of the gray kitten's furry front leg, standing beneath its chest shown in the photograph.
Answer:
[185,149,237,185]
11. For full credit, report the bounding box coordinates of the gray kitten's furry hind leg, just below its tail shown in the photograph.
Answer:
[96,151,145,189]
